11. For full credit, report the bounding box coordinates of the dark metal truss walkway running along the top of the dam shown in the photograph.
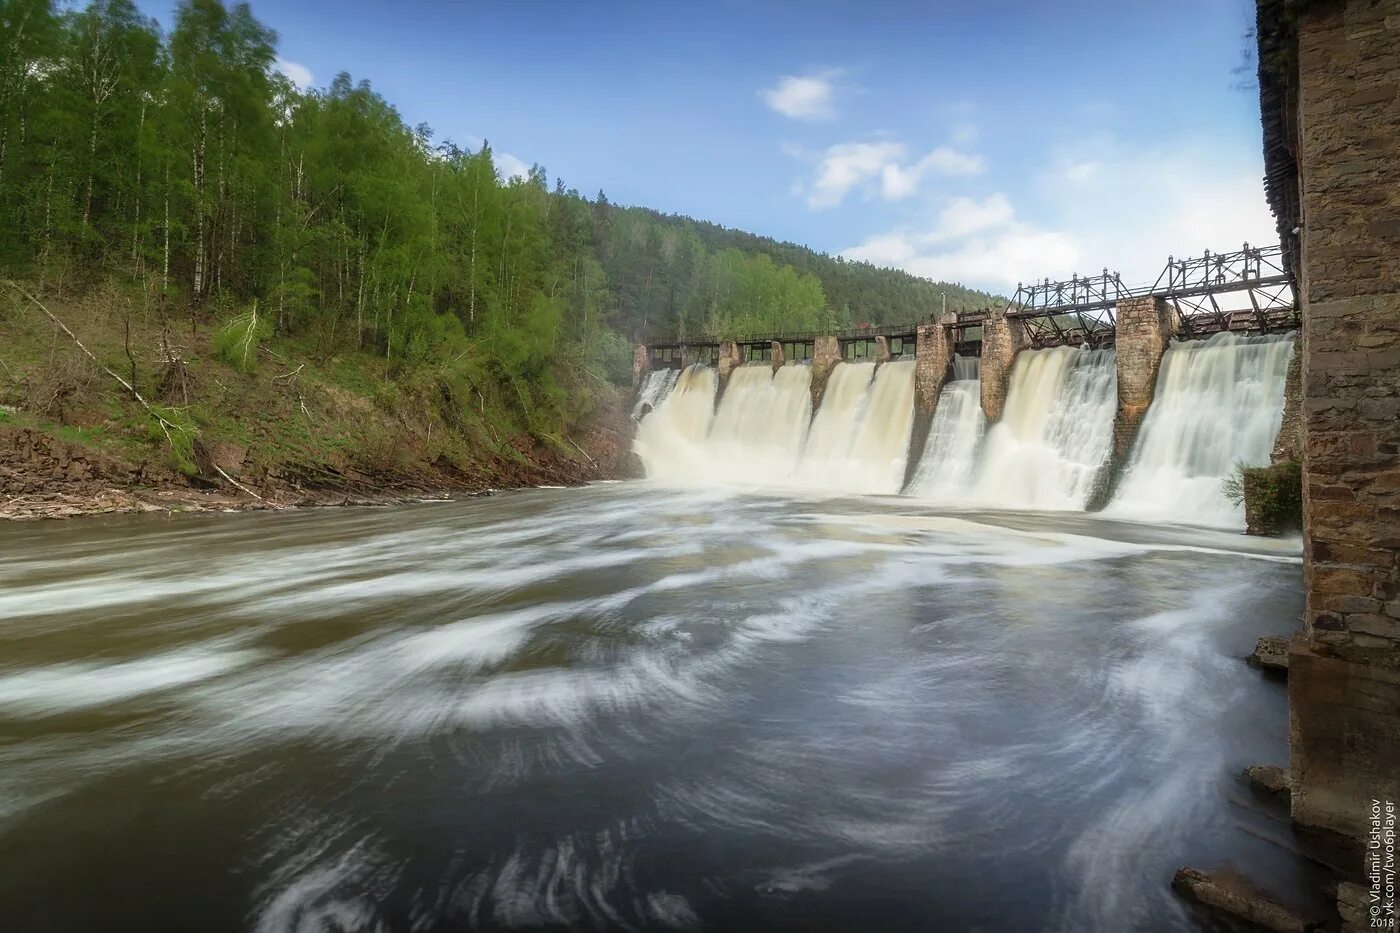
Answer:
[647,242,1299,368]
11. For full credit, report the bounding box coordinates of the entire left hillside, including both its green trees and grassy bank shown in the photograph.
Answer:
[0,0,987,515]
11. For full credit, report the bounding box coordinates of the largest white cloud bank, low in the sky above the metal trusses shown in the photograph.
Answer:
[841,140,1277,288]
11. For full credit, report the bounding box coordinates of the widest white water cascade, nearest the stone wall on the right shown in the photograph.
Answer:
[1106,333,1294,528]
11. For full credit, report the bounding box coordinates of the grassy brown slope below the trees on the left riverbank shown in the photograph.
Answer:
[0,280,619,498]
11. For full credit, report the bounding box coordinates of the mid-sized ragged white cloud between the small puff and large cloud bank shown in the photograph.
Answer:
[806,140,986,210]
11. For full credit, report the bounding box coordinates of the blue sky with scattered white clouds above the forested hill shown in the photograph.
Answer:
[141,0,1277,293]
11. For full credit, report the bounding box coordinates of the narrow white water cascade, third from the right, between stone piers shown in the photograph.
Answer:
[909,356,987,503]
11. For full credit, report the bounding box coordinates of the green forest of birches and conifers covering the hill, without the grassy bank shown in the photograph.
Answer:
[0,0,1008,479]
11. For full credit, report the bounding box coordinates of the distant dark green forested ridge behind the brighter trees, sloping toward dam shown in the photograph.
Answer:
[615,207,1002,336]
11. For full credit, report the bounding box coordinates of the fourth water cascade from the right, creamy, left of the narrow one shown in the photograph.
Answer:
[798,360,914,493]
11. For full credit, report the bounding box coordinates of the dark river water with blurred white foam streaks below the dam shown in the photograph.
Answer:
[0,483,1303,932]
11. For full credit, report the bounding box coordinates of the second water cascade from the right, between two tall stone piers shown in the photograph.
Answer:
[959,346,1117,510]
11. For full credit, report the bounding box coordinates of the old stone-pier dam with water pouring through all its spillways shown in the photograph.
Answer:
[634,247,1298,530]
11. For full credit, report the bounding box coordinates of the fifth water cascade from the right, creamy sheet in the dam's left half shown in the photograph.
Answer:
[704,363,812,486]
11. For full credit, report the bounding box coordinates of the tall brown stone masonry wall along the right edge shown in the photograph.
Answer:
[1274,0,1400,834]
